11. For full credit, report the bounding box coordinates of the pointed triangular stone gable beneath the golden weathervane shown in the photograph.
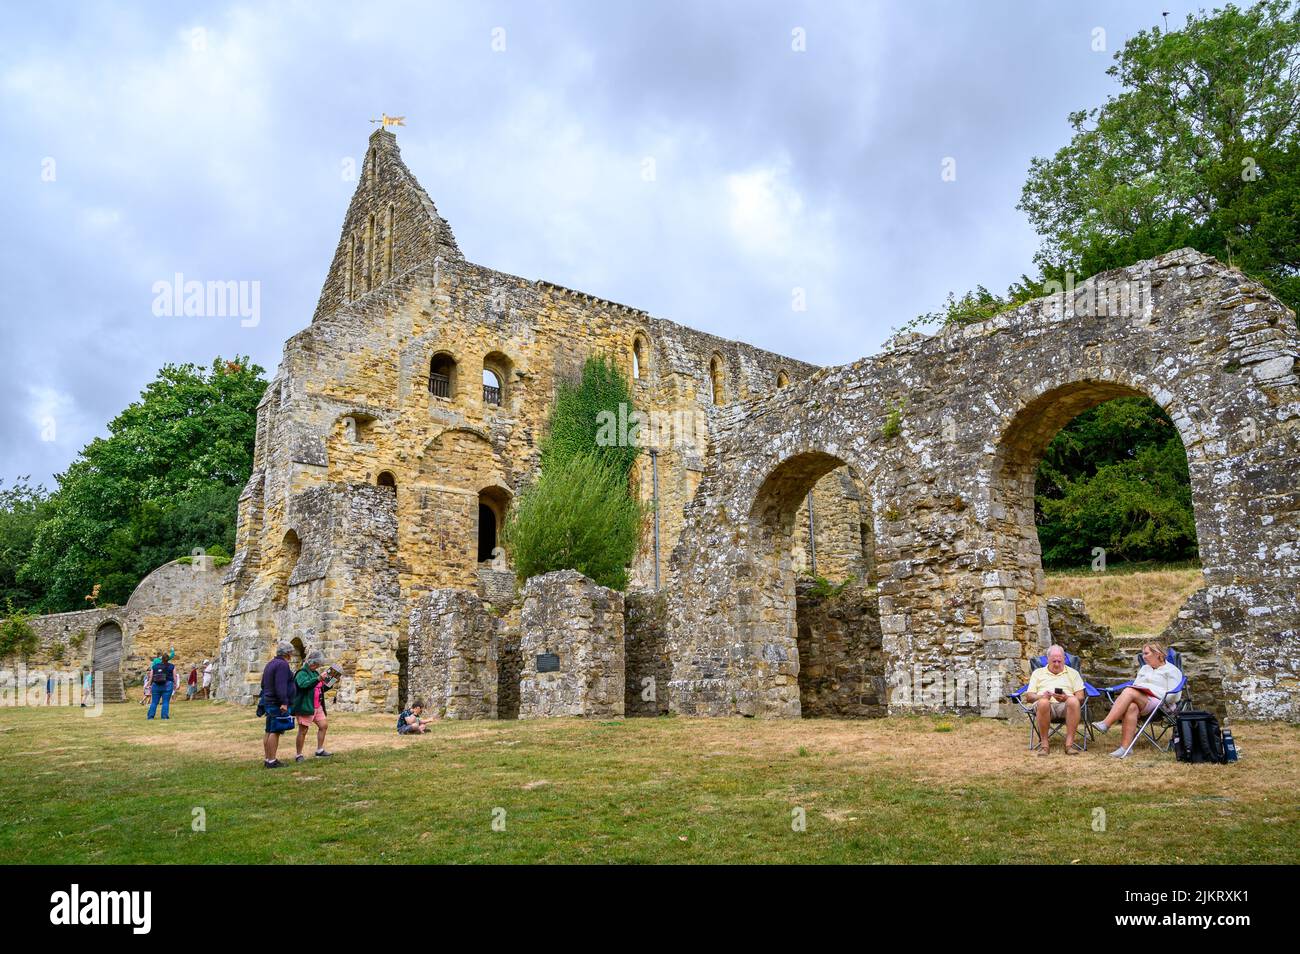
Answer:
[312,129,464,321]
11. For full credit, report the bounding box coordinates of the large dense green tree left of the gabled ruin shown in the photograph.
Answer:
[18,357,267,612]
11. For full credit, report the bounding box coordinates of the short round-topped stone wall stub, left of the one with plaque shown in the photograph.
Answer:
[403,589,499,719]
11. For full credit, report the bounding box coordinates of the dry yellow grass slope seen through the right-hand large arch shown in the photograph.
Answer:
[1048,567,1204,636]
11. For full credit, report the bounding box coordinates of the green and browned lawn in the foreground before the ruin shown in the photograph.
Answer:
[0,702,1300,864]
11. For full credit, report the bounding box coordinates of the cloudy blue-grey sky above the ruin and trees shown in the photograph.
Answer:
[0,0,1195,485]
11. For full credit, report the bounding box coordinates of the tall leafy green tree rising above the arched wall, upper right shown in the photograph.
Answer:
[1019,0,1300,314]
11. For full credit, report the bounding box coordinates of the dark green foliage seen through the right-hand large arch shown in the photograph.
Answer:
[1035,398,1197,567]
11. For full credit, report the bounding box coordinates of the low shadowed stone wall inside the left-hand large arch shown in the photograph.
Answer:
[796,580,887,719]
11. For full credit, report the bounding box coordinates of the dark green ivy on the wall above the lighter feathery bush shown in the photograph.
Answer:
[542,355,640,476]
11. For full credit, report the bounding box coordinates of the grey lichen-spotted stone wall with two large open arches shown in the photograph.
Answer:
[668,250,1300,717]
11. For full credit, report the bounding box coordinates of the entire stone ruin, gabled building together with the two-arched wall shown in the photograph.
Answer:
[202,131,1300,719]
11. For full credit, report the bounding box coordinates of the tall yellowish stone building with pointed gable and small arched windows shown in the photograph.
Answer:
[220,131,863,708]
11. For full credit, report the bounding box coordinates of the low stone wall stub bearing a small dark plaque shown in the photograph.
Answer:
[519,569,625,719]
